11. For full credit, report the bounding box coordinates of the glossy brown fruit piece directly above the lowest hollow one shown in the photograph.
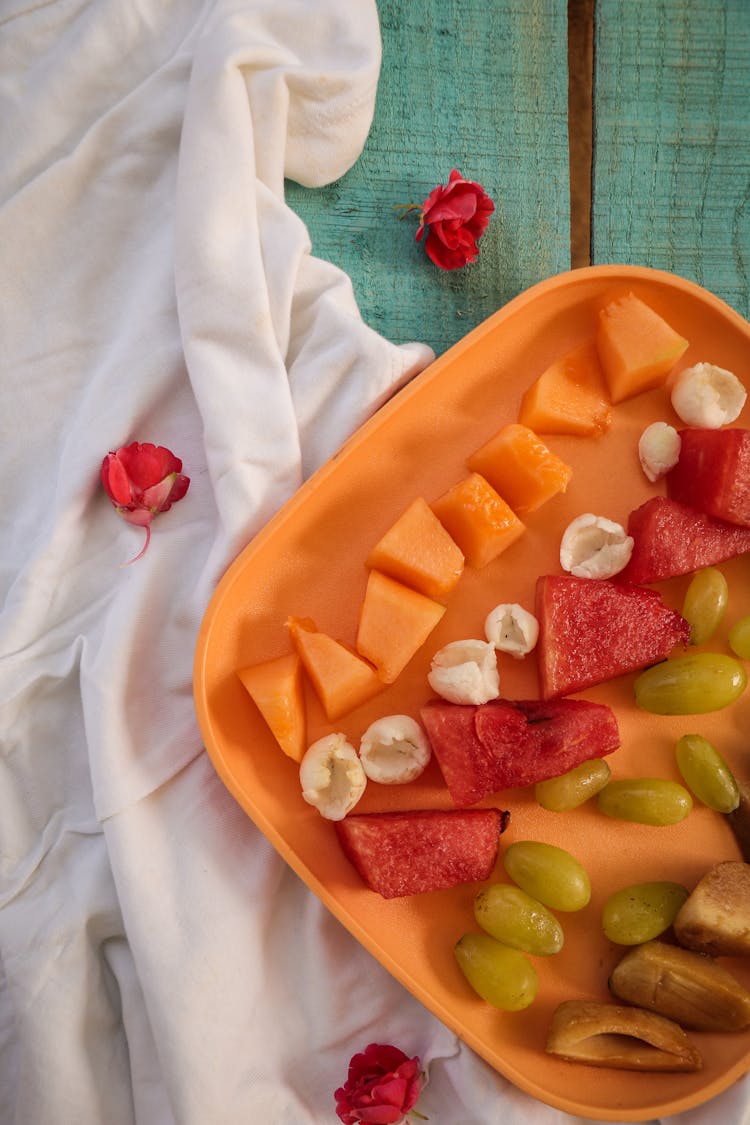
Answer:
[609,942,750,1032]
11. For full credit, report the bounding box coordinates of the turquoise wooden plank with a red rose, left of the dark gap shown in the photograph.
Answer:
[287,0,570,354]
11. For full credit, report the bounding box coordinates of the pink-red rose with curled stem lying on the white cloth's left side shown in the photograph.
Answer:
[101,441,190,563]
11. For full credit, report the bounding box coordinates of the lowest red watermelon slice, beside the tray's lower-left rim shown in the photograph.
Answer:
[335,809,509,899]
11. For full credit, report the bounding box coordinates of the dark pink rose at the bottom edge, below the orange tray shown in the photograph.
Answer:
[334,1043,422,1125]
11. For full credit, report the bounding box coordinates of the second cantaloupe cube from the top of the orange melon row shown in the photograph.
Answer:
[518,340,612,437]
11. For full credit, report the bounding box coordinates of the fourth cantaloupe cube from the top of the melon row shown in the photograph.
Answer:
[432,473,526,569]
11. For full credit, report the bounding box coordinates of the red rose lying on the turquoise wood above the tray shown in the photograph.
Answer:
[416,168,495,270]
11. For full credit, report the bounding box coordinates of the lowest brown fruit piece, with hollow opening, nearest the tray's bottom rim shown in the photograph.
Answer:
[546,1000,703,1071]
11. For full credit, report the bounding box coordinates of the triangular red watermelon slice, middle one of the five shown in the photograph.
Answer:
[536,575,690,700]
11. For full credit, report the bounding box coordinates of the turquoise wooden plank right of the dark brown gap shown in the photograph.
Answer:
[591,0,750,316]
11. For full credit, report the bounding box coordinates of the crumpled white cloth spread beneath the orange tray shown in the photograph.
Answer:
[0,0,750,1125]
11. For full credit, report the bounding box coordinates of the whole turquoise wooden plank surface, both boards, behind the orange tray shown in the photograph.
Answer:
[288,0,750,354]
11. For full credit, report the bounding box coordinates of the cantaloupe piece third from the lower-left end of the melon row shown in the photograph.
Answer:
[356,570,445,684]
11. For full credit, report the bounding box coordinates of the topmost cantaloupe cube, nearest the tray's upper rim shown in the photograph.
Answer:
[596,293,689,403]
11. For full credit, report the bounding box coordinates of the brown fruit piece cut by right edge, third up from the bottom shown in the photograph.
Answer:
[675,860,750,957]
